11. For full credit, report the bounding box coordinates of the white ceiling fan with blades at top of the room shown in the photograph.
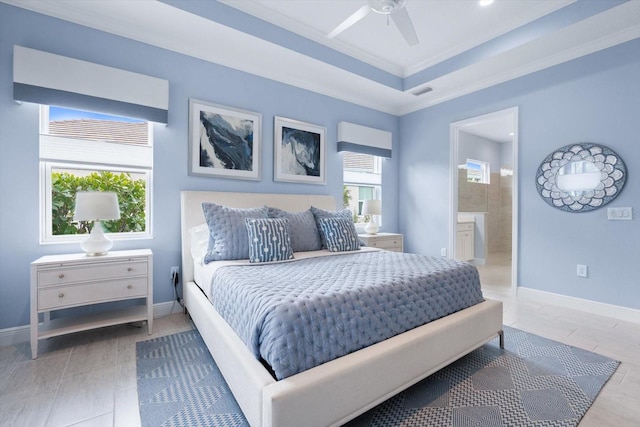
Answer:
[327,0,418,46]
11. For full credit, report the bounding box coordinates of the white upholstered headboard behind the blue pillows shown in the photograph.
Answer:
[180,191,338,283]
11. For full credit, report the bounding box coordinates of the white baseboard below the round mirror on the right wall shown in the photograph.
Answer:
[517,287,640,324]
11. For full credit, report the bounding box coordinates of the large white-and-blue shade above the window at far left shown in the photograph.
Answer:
[13,46,169,123]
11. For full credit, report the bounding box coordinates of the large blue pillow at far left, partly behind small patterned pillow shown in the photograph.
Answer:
[202,202,267,264]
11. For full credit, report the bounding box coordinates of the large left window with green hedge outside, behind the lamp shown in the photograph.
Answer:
[40,106,153,243]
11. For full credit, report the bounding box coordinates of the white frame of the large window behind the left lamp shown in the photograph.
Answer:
[38,105,153,245]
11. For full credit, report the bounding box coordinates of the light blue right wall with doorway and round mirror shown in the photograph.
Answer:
[399,40,640,309]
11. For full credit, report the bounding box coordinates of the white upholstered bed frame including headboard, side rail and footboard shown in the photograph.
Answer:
[181,191,502,427]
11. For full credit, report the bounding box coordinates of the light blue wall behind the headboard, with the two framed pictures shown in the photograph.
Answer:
[0,3,398,329]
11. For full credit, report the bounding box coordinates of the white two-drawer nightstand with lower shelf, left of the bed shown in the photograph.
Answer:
[31,249,153,359]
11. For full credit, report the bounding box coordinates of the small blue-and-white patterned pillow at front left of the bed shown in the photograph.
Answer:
[244,218,293,262]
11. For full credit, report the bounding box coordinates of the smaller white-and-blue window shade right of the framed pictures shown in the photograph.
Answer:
[338,122,392,157]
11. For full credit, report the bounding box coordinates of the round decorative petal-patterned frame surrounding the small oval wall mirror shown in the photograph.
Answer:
[536,142,627,212]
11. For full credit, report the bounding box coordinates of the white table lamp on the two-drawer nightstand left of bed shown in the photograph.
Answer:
[73,191,120,256]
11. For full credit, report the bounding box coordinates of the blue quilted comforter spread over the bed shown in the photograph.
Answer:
[210,251,483,379]
